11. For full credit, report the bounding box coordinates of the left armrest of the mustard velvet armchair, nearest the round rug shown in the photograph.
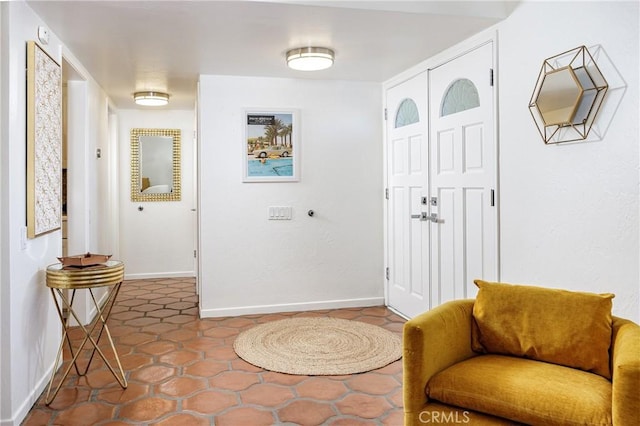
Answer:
[402,300,475,413]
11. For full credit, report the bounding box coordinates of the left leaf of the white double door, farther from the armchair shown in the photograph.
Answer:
[386,72,430,316]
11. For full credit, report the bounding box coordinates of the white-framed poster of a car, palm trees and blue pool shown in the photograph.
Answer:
[242,109,300,182]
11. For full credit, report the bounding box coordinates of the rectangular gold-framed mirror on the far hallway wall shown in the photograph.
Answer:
[131,128,181,201]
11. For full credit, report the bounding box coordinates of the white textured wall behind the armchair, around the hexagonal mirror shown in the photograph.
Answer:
[498,2,640,322]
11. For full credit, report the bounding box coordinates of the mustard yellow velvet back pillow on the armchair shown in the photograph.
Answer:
[472,280,614,379]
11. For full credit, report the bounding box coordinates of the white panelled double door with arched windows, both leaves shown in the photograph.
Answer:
[386,43,498,317]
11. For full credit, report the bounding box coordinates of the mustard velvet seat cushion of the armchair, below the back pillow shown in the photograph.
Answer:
[426,355,612,425]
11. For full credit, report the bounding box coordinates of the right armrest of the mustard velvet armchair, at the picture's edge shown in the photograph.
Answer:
[611,317,640,426]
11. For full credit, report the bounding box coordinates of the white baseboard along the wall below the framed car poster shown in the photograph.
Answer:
[200,297,384,318]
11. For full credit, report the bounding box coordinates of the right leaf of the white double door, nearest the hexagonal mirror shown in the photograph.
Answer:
[429,43,498,306]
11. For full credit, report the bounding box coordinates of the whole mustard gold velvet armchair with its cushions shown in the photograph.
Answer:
[403,281,640,426]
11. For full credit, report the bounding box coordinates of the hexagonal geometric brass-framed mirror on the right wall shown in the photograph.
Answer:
[529,46,609,144]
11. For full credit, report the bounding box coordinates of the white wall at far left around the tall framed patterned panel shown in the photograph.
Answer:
[0,2,61,424]
